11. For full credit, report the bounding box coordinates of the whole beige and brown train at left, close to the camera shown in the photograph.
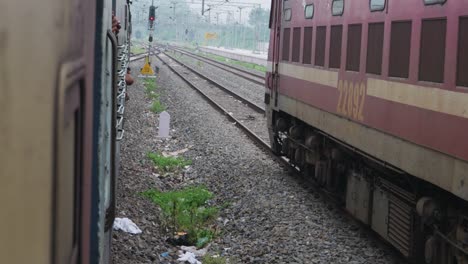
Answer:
[0,0,132,264]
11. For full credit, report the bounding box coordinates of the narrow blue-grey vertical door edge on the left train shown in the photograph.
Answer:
[91,0,114,263]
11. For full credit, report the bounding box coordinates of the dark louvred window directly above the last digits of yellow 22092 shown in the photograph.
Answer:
[346,24,362,71]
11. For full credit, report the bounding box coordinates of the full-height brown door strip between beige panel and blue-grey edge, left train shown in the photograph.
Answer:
[52,0,95,263]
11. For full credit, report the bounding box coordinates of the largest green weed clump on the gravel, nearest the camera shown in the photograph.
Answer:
[143,186,219,248]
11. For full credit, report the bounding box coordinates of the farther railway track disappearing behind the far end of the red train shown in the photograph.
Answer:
[169,47,265,86]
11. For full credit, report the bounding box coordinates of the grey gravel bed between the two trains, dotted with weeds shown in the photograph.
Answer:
[112,56,401,263]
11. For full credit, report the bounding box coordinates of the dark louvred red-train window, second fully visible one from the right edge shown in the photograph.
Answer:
[388,21,411,78]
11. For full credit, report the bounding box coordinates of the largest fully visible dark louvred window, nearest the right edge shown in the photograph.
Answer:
[419,19,447,83]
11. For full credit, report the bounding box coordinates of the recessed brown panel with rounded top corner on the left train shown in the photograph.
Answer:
[54,61,84,263]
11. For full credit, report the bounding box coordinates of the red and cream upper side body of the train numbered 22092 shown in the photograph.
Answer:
[270,1,468,200]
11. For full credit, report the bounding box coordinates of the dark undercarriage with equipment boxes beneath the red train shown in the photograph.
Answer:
[267,110,468,264]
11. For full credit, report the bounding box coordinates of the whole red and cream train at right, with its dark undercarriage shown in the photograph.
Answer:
[265,0,468,264]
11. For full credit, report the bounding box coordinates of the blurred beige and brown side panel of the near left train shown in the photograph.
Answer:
[0,0,95,263]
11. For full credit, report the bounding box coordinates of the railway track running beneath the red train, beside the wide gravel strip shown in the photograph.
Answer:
[153,52,406,263]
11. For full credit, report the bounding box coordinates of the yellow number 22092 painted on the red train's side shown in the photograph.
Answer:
[337,80,366,121]
